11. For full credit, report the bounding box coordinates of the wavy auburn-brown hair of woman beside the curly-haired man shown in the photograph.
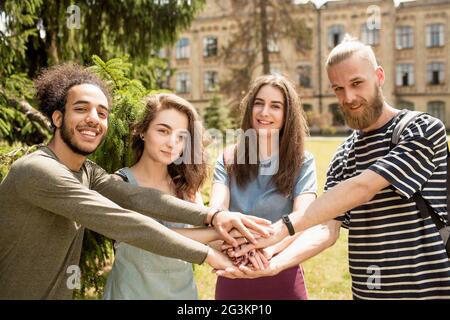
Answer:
[131,93,207,201]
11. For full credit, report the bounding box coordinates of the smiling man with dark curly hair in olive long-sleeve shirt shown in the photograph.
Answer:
[0,64,266,299]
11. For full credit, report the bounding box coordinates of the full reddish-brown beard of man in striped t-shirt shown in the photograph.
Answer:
[341,86,384,130]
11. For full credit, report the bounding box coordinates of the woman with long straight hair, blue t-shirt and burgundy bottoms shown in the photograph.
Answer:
[211,75,317,300]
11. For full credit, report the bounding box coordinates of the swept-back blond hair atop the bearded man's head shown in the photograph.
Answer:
[325,34,378,69]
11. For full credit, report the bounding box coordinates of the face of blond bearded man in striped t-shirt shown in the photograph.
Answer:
[327,53,384,130]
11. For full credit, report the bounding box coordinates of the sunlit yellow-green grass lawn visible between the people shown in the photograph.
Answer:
[195,139,351,300]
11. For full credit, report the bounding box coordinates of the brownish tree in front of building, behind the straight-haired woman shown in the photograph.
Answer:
[217,0,311,121]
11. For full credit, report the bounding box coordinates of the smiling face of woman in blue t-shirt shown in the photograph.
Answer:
[252,85,285,132]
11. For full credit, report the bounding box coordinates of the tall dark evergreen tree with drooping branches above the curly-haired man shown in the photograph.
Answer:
[0,0,204,145]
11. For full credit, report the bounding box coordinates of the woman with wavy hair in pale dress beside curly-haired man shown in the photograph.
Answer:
[104,94,218,300]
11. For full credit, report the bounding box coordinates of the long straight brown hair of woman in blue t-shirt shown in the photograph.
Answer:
[226,75,308,197]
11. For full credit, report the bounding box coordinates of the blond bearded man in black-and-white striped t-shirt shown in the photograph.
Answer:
[217,36,450,299]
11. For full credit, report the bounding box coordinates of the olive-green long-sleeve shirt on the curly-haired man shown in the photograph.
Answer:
[0,147,208,299]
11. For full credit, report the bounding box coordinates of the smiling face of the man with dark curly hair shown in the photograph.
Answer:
[52,84,109,156]
